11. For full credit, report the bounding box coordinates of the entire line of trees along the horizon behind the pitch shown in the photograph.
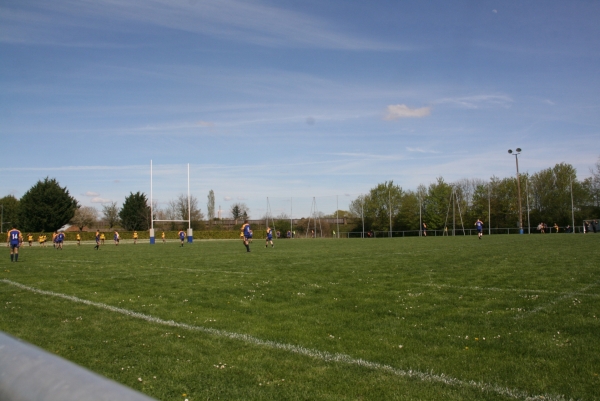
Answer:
[0,158,600,232]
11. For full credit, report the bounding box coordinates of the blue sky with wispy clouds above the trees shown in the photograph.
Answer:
[0,0,600,218]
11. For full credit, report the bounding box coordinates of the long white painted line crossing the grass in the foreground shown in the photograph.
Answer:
[0,279,580,401]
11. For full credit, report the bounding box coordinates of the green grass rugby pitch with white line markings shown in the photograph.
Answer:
[0,234,600,401]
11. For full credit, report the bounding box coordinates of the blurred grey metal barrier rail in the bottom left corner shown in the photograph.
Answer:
[0,332,155,401]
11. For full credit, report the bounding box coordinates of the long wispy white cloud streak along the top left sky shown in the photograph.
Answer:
[0,0,409,51]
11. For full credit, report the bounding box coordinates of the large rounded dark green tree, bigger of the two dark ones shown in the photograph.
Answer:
[19,177,78,231]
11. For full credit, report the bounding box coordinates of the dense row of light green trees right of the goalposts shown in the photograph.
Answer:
[349,159,600,231]
